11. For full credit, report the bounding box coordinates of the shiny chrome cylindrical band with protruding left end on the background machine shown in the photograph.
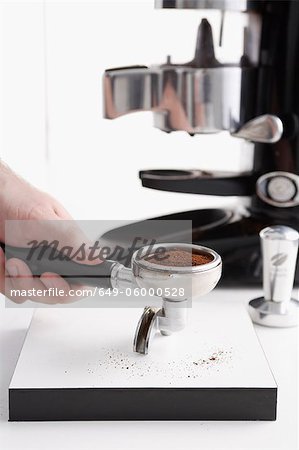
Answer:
[104,66,256,134]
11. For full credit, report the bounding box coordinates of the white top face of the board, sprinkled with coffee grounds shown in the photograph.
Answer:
[10,306,276,389]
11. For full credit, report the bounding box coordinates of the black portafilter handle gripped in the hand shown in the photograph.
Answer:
[0,242,117,289]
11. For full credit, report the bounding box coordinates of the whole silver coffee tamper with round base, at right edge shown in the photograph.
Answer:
[249,225,299,327]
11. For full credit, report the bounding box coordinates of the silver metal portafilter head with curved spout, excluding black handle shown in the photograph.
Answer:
[132,244,222,354]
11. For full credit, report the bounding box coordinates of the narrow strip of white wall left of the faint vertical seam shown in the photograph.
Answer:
[0,1,46,187]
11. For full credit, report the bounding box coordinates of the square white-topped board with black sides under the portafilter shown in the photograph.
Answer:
[9,296,277,421]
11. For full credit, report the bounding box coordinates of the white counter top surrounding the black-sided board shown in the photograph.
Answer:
[0,289,298,450]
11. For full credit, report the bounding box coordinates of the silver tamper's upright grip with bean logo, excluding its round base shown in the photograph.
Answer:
[260,225,299,303]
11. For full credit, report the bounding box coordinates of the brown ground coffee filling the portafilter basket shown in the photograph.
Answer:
[145,249,213,267]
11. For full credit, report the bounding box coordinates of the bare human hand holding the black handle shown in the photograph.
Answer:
[0,162,95,304]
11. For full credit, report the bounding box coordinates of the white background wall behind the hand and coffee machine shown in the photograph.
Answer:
[2,0,255,219]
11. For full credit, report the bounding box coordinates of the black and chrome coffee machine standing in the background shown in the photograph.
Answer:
[103,0,299,286]
